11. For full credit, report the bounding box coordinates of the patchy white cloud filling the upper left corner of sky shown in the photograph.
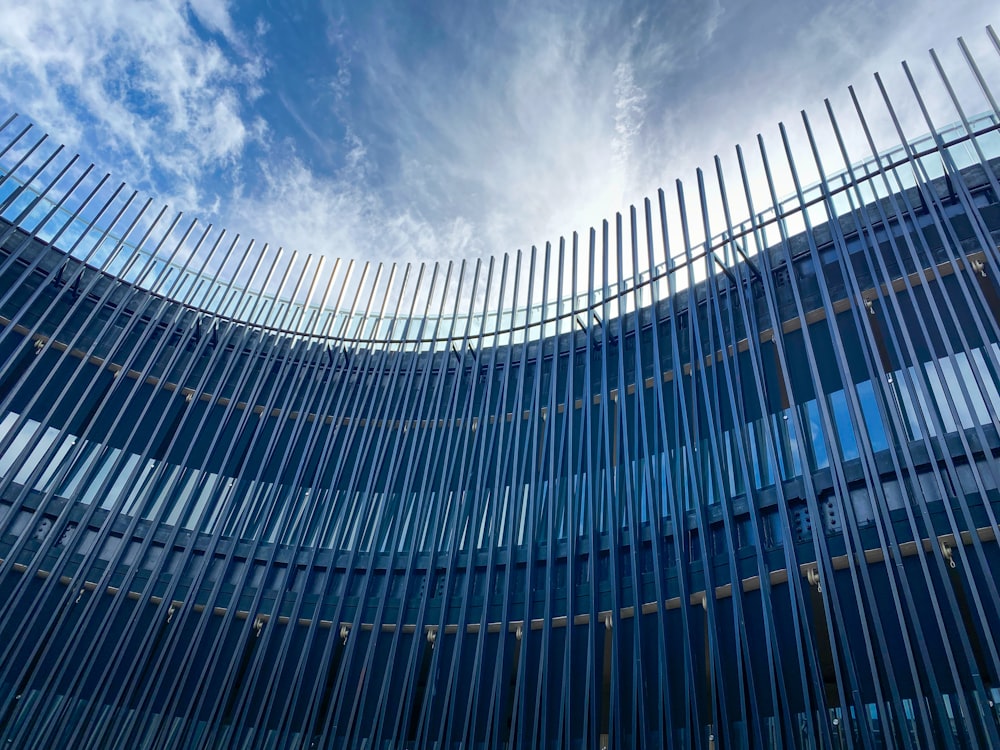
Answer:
[0,0,266,205]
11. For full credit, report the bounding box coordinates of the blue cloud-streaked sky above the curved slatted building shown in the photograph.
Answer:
[0,0,1000,270]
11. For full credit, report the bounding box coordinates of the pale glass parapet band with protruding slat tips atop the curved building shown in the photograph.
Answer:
[0,113,1000,349]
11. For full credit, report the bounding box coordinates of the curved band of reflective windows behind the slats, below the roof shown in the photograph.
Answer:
[0,344,1000,551]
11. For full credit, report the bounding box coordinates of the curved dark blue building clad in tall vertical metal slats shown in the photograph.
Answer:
[0,42,1000,748]
